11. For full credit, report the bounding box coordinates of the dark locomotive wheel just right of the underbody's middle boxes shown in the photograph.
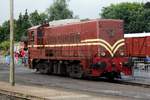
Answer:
[69,65,83,78]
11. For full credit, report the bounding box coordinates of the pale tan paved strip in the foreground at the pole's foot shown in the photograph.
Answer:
[0,82,139,100]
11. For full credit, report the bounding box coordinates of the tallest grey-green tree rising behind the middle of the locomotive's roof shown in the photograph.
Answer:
[47,0,73,21]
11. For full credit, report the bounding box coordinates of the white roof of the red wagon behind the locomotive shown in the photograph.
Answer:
[124,33,150,38]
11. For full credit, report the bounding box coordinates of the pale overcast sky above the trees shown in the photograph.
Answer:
[0,0,150,24]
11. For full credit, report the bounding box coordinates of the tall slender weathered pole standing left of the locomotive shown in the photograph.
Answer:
[9,0,15,86]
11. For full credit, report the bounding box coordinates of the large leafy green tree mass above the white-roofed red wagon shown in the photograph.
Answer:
[100,3,150,33]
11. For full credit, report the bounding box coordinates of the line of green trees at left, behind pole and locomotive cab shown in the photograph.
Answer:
[0,0,77,42]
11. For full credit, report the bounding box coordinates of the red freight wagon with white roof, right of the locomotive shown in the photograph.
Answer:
[124,33,150,58]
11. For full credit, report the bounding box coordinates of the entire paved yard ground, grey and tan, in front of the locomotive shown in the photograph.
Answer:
[0,61,150,100]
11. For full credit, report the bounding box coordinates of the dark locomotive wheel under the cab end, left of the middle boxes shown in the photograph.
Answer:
[37,63,49,74]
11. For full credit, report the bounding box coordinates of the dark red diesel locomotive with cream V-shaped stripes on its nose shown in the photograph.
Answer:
[28,19,131,78]
